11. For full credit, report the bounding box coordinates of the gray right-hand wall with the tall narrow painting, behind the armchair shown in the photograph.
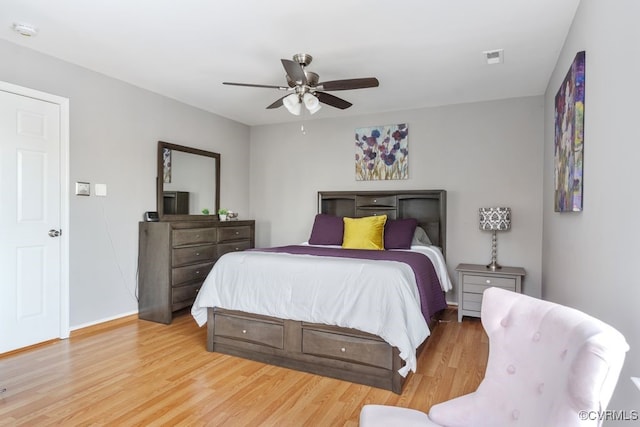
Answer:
[542,0,640,425]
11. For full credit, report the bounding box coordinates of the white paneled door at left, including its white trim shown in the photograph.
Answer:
[0,84,69,353]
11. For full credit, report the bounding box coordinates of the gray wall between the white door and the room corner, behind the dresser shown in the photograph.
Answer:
[0,40,249,328]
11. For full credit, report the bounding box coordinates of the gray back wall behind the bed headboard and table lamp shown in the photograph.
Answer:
[250,96,544,301]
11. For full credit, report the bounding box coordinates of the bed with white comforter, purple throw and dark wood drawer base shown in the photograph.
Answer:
[192,190,451,394]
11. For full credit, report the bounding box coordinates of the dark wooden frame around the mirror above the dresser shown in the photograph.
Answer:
[156,141,220,221]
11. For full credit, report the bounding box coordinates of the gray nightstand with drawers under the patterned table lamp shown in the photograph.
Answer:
[456,264,525,322]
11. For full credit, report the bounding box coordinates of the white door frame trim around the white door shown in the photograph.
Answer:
[0,80,70,339]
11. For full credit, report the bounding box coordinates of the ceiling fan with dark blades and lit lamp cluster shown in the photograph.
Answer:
[222,53,380,116]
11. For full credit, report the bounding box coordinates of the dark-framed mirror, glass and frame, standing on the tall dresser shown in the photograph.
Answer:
[156,141,220,220]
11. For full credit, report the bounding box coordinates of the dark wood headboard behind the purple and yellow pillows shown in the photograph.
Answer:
[318,190,447,257]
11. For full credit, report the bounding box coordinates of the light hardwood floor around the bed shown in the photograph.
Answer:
[0,310,488,426]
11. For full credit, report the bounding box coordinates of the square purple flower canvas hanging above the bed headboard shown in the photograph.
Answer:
[355,123,409,181]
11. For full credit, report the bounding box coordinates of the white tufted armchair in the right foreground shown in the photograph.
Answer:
[360,288,629,427]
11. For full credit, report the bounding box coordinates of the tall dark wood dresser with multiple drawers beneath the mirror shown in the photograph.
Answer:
[138,220,255,324]
